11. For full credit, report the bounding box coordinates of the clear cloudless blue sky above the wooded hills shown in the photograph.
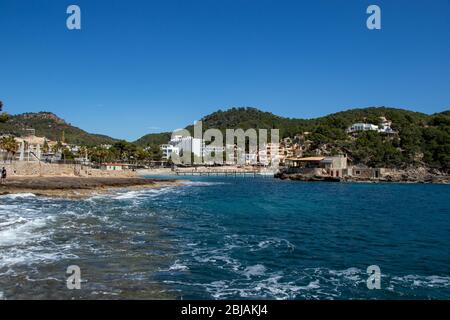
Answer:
[0,0,450,140]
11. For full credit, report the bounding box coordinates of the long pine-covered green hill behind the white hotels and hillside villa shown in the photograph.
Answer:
[135,107,450,169]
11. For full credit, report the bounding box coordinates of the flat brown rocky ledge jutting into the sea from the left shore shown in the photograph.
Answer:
[0,176,181,198]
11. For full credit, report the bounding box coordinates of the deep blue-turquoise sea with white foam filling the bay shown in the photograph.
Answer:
[0,177,450,299]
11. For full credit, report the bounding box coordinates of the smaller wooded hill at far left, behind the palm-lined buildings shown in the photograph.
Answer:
[0,112,117,146]
